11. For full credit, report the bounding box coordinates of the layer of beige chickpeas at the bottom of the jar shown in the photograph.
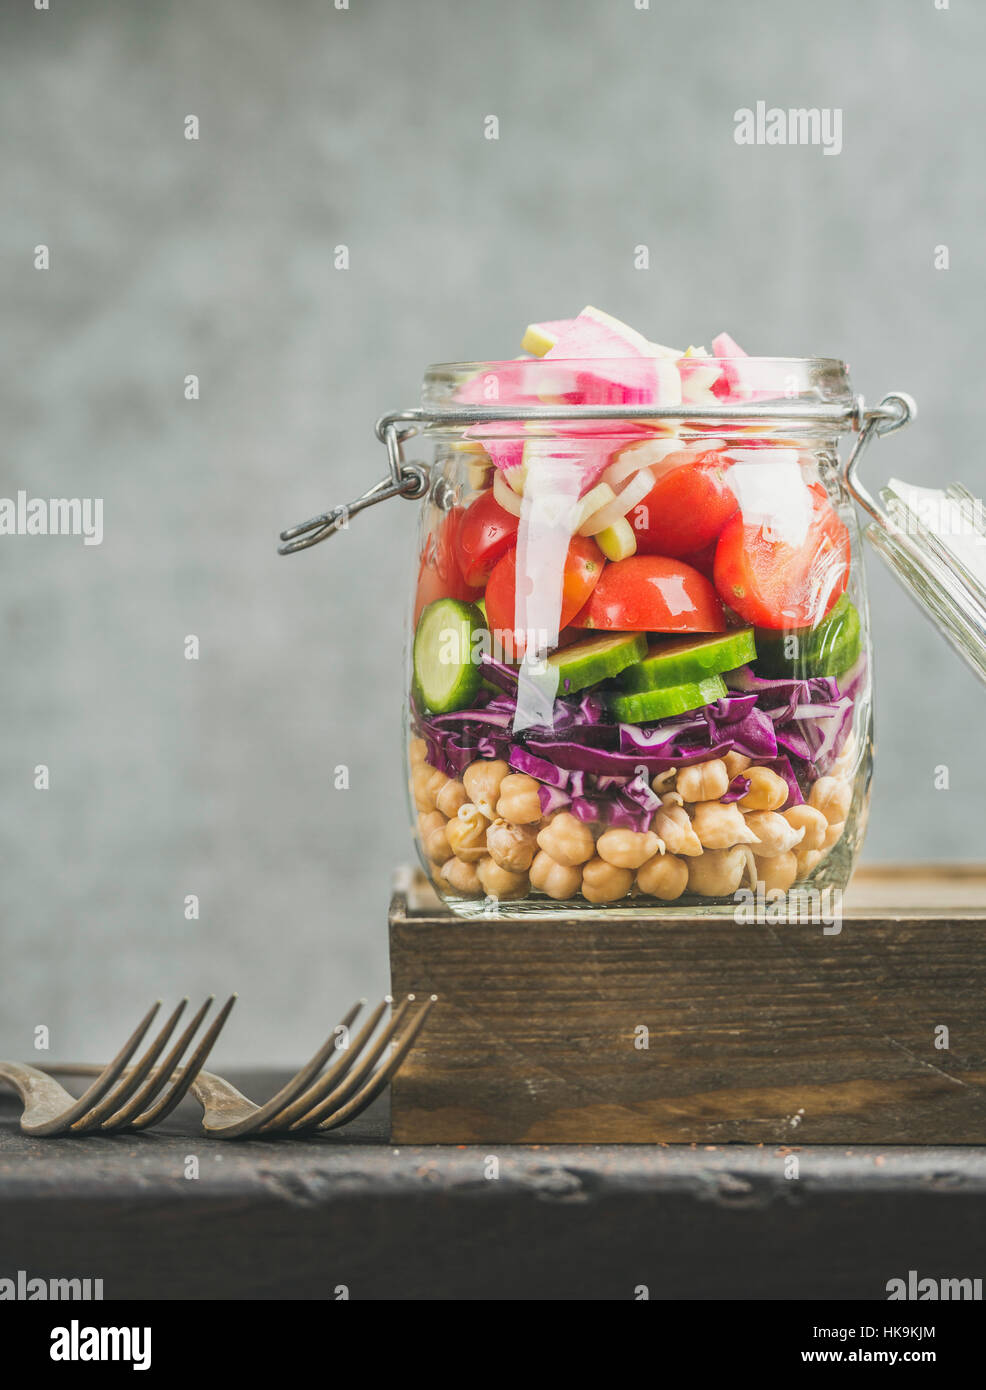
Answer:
[409,738,857,905]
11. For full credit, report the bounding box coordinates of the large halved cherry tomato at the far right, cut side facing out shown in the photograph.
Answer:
[715,482,850,628]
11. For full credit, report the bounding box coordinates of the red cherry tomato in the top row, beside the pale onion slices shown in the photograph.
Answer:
[629,449,736,559]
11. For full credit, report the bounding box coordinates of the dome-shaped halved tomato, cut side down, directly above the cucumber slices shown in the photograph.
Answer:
[572,555,726,632]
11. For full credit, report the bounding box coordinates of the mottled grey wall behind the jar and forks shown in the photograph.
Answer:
[0,0,986,1062]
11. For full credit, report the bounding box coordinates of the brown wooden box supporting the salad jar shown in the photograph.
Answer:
[389,865,986,1144]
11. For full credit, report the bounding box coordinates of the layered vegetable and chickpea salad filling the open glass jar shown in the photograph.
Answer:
[409,307,869,908]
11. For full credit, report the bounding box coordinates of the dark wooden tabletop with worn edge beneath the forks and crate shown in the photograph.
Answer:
[0,1073,986,1298]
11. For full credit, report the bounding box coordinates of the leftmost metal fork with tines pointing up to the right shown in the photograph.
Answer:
[0,994,236,1137]
